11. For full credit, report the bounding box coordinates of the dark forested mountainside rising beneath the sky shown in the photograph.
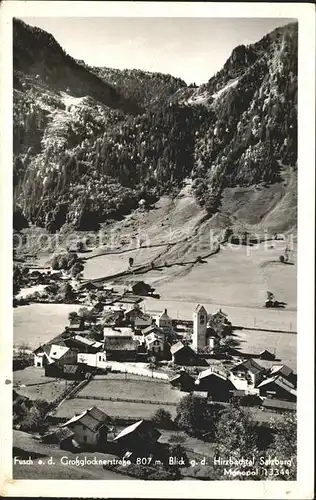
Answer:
[13,20,297,231]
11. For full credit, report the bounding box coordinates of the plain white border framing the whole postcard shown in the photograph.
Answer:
[0,1,315,499]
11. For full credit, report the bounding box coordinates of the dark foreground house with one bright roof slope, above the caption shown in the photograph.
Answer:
[113,420,161,451]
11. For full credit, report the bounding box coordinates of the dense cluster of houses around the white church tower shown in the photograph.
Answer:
[30,290,296,411]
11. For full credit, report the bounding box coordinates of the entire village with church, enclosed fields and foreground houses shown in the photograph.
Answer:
[13,254,297,480]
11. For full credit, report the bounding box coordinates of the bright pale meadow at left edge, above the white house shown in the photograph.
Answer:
[13,304,81,349]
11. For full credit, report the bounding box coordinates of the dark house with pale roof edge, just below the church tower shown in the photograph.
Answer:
[195,367,235,401]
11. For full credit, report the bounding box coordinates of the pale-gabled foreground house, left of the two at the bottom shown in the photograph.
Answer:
[62,406,111,449]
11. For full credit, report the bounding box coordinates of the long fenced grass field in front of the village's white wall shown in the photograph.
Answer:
[77,376,183,402]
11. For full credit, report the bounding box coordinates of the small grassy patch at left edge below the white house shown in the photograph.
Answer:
[13,366,69,401]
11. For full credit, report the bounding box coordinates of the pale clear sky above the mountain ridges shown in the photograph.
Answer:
[22,17,294,85]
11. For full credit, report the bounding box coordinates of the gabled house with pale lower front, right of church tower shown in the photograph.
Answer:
[229,358,265,390]
